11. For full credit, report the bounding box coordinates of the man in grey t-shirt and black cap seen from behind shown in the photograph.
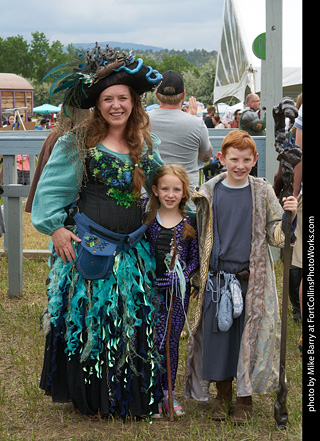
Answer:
[149,70,212,209]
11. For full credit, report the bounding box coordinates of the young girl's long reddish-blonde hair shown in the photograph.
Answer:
[145,164,196,239]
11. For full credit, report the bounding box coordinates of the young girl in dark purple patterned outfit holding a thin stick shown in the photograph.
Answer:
[146,164,199,417]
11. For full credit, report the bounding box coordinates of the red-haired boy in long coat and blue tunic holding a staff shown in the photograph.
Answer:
[184,130,297,424]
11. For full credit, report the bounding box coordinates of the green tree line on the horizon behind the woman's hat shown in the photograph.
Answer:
[0,31,217,107]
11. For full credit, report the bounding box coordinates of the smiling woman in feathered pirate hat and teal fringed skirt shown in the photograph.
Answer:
[31,44,163,420]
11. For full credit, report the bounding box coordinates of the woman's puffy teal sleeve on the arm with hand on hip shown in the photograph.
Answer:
[31,135,83,235]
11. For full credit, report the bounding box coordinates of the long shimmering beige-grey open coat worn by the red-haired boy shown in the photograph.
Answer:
[184,173,284,401]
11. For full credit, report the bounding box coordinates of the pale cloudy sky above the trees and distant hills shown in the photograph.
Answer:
[0,0,223,51]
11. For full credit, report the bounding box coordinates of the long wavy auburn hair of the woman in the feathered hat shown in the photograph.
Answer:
[86,87,152,194]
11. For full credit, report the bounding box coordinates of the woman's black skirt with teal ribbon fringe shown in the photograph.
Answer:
[40,235,162,418]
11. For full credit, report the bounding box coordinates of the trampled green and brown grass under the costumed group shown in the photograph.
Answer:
[0,212,302,441]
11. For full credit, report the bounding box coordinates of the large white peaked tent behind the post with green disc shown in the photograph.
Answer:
[213,0,302,103]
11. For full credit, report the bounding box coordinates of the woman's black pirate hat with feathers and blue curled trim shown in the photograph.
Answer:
[42,43,162,110]
